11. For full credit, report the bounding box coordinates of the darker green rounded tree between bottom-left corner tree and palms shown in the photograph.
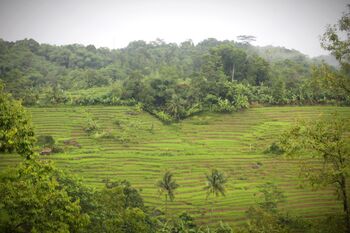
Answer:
[90,180,158,233]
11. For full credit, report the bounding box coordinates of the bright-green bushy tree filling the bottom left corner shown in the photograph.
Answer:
[0,160,90,232]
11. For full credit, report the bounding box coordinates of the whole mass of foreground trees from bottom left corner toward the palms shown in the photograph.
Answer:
[0,159,162,233]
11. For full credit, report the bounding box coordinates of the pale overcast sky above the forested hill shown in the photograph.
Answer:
[0,0,349,56]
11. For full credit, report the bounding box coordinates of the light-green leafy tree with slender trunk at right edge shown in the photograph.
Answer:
[281,115,350,232]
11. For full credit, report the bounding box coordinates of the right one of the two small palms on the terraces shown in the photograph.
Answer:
[204,169,227,215]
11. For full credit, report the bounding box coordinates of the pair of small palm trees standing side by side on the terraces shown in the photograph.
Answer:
[156,169,227,215]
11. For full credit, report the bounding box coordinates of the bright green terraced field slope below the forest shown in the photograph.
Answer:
[0,106,350,224]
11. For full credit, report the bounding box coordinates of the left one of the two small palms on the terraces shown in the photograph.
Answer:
[157,171,179,214]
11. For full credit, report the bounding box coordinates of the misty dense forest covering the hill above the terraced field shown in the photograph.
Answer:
[0,7,350,122]
